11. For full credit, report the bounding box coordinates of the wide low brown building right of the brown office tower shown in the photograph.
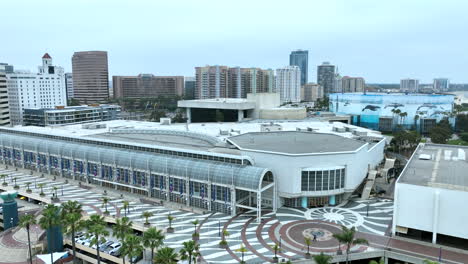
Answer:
[112,74,184,98]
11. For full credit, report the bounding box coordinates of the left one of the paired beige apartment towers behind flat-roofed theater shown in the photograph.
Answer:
[195,65,229,99]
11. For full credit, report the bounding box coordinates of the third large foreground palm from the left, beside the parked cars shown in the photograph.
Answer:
[62,201,83,263]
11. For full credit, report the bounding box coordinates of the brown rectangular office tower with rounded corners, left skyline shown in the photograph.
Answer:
[72,51,109,103]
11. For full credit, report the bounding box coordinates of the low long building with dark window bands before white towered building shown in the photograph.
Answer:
[23,105,121,127]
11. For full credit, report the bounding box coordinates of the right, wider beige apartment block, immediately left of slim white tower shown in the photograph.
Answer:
[228,67,275,98]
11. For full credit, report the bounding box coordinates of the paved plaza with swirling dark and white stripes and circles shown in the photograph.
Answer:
[0,169,466,264]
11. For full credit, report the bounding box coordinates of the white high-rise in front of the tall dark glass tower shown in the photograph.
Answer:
[276,66,301,103]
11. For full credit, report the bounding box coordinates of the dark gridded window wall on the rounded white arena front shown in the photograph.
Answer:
[301,168,346,192]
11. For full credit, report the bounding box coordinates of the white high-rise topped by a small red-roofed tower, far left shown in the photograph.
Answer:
[6,53,67,125]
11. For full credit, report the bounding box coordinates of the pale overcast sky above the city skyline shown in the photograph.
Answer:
[0,0,468,83]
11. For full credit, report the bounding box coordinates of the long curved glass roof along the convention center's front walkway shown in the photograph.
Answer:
[0,134,268,191]
